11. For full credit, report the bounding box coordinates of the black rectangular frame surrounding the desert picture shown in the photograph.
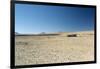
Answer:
[10,1,97,69]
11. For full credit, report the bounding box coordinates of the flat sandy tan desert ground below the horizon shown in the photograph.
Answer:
[15,31,94,65]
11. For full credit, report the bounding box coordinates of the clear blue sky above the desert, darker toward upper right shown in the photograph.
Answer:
[15,4,95,34]
